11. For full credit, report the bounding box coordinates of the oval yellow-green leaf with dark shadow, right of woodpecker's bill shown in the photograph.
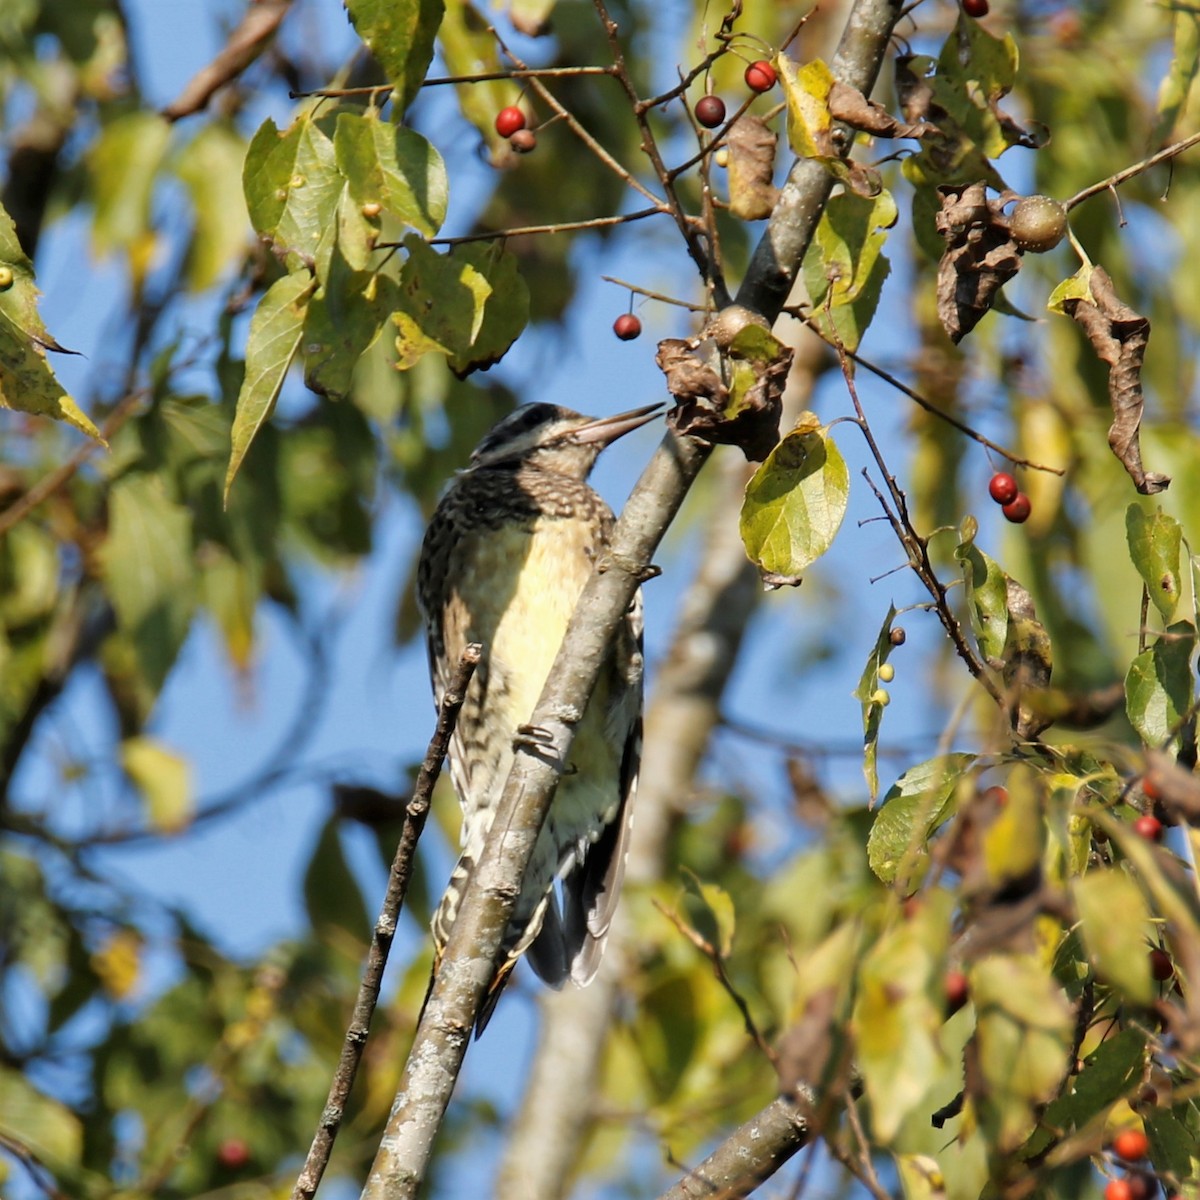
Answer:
[739,413,850,582]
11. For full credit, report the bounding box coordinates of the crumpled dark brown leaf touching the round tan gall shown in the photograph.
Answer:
[935,182,1021,342]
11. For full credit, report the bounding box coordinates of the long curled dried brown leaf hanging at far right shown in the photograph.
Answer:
[1062,266,1171,496]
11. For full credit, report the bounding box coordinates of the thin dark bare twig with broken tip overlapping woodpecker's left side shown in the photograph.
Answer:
[292,642,484,1200]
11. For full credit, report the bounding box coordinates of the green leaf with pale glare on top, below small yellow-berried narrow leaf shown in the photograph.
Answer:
[866,754,976,883]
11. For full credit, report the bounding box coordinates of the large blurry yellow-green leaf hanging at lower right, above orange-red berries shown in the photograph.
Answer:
[971,954,1075,1152]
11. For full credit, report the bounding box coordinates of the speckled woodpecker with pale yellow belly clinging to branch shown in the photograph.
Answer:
[416,403,662,1037]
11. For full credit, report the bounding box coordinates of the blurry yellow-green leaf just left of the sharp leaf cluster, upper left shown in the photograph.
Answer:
[175,122,250,292]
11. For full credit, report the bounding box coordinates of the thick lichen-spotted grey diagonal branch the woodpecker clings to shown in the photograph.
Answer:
[362,0,900,1200]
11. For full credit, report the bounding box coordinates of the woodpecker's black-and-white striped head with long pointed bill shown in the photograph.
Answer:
[470,404,662,479]
